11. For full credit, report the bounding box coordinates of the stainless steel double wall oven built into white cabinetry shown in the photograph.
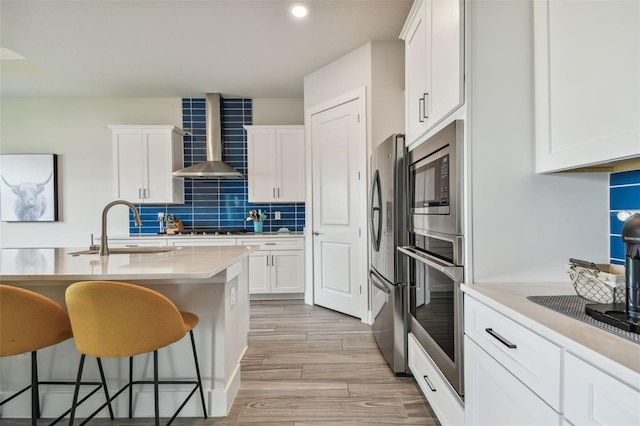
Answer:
[398,120,464,396]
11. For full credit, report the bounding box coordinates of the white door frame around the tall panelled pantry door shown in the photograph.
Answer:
[304,87,371,324]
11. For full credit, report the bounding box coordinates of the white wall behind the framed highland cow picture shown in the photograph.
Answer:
[0,98,182,247]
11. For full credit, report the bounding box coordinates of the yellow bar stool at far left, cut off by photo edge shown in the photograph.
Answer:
[0,284,113,426]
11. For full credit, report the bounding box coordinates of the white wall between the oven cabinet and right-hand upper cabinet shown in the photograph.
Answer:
[466,0,608,282]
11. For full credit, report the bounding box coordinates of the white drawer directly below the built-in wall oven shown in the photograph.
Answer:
[408,333,464,425]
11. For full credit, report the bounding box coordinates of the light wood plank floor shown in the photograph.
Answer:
[0,300,440,426]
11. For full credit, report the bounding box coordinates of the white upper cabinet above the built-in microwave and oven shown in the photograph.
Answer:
[400,0,464,145]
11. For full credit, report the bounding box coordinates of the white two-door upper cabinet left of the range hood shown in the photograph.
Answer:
[109,125,184,204]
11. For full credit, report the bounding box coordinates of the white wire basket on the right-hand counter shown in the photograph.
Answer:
[567,259,626,303]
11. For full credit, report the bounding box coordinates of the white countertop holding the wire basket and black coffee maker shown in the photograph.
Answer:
[462,282,640,382]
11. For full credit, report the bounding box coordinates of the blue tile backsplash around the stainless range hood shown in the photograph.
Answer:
[129,98,305,235]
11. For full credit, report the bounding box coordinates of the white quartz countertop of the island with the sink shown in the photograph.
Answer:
[0,245,257,281]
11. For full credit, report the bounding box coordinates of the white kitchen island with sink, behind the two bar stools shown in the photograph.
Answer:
[0,246,256,418]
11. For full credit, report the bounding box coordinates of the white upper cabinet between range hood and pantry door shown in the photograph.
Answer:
[244,126,305,203]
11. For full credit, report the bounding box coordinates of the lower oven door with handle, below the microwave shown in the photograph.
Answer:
[398,246,464,396]
